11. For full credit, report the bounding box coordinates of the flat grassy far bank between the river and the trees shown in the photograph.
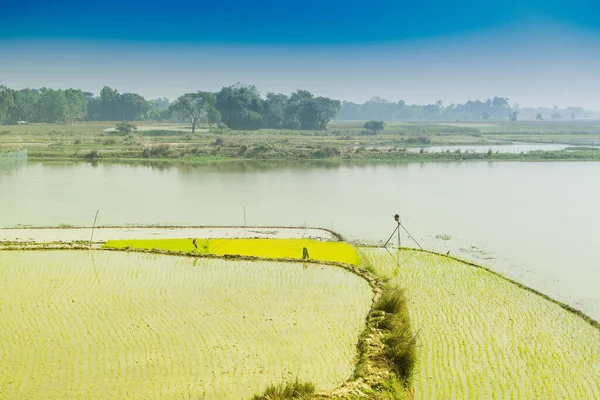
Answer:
[0,122,600,163]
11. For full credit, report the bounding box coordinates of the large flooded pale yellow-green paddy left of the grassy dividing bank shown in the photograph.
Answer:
[0,251,372,400]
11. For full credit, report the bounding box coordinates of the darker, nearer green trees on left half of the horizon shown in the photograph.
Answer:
[0,83,341,130]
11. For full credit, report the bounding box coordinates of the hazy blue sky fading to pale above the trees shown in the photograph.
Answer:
[0,0,600,110]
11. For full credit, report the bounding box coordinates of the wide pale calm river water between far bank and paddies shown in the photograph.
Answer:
[0,162,600,320]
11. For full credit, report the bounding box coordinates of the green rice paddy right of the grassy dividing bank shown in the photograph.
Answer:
[361,249,600,399]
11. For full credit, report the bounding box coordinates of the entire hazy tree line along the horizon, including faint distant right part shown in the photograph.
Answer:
[0,83,597,130]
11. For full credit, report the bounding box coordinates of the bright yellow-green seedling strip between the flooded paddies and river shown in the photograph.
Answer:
[103,239,360,265]
